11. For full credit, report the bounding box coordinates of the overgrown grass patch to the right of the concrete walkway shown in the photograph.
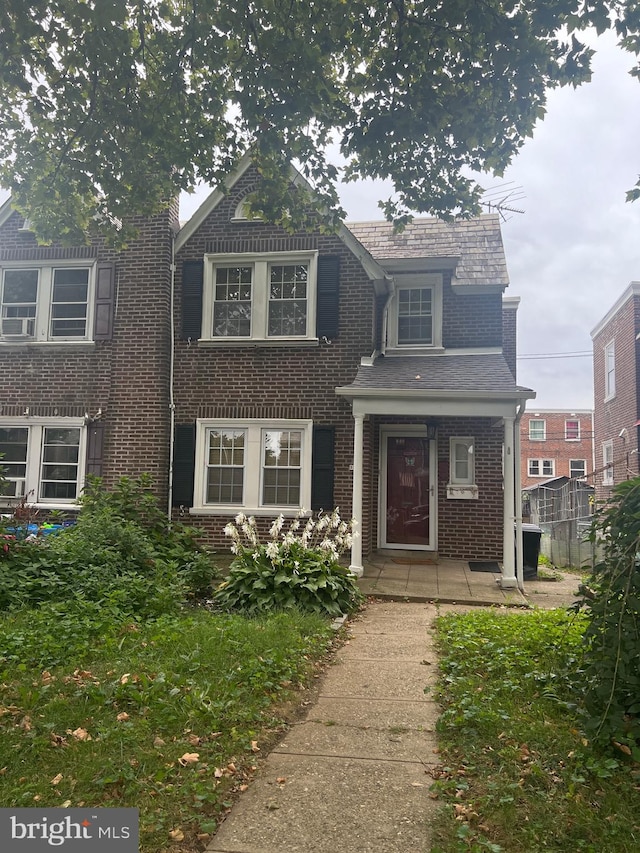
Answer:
[432,610,640,853]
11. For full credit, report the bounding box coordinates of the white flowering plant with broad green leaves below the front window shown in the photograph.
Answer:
[213,508,363,617]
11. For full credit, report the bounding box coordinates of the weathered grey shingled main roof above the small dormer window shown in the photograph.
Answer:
[347,213,509,287]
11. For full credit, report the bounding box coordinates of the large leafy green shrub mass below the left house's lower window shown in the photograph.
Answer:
[0,476,219,618]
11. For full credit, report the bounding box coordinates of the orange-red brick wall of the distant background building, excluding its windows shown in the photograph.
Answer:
[520,412,593,486]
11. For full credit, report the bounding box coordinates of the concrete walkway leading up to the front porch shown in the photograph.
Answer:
[207,602,439,853]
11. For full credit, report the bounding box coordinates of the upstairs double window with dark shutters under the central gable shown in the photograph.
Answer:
[203,252,317,342]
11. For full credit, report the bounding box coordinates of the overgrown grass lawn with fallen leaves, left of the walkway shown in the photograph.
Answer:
[0,601,333,853]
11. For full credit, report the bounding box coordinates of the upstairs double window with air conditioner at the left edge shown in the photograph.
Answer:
[0,266,92,342]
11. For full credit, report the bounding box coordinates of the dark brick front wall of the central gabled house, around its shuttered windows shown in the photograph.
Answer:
[175,173,376,550]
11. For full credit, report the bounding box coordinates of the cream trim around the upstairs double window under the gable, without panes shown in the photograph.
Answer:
[200,251,318,346]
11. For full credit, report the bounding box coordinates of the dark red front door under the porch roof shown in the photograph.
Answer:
[381,435,432,548]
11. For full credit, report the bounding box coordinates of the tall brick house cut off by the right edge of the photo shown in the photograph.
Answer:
[591,281,640,492]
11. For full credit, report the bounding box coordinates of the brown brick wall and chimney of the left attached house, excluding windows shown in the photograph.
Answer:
[0,205,177,500]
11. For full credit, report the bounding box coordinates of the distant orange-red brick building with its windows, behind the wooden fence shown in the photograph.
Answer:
[520,409,594,488]
